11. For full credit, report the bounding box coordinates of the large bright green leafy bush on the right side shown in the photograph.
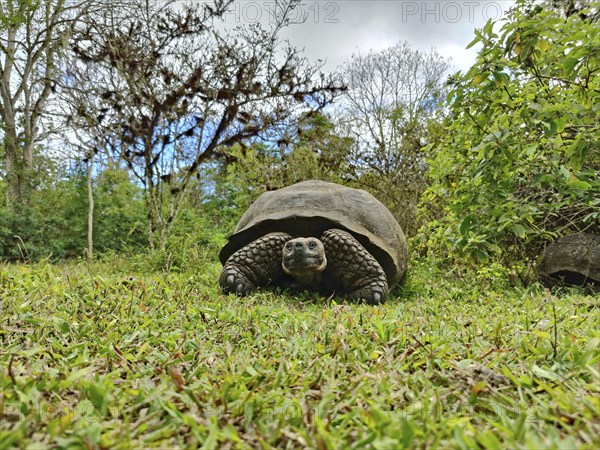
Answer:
[422,0,600,264]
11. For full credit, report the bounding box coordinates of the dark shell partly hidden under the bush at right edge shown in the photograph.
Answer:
[538,233,600,288]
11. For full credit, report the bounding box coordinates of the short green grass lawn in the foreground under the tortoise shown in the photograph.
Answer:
[0,255,600,449]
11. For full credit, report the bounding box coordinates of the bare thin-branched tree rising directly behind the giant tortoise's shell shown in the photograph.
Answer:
[343,43,449,234]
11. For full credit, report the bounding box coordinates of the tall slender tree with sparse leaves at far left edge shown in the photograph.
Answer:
[0,0,83,210]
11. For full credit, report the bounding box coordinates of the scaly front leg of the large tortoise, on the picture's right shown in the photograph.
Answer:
[321,229,388,305]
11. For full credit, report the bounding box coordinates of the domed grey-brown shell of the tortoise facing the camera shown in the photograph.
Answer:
[219,180,408,286]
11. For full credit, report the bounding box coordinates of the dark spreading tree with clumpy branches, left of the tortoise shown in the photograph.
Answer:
[64,0,341,248]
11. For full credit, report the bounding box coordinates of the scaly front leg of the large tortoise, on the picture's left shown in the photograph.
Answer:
[219,233,292,295]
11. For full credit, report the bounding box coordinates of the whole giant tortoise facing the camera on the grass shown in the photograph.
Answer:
[219,181,407,304]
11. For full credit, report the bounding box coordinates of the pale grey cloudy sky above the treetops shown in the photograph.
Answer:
[227,0,514,74]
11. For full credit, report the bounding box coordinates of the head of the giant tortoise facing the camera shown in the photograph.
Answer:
[281,237,327,287]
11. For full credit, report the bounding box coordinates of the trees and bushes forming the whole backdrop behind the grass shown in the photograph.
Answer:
[0,1,600,270]
